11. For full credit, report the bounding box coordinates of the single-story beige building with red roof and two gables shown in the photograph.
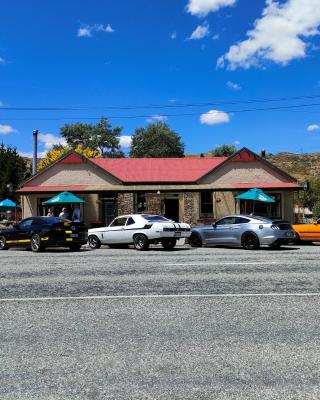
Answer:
[18,148,301,225]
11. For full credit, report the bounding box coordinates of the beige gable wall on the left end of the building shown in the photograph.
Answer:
[25,163,119,187]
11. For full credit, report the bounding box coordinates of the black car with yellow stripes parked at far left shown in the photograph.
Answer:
[0,217,88,252]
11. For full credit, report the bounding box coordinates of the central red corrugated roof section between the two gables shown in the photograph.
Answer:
[91,157,227,183]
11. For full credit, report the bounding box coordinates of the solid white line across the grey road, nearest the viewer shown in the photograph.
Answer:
[0,292,320,303]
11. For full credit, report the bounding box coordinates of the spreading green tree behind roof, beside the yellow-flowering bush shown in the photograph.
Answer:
[60,117,124,157]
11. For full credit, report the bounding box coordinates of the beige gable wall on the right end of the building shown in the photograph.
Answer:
[199,161,290,187]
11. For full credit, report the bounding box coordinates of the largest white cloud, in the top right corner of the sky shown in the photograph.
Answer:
[217,0,320,70]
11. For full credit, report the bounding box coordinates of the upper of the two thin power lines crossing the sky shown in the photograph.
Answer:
[0,94,320,111]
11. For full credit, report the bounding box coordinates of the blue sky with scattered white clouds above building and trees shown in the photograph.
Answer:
[0,0,320,153]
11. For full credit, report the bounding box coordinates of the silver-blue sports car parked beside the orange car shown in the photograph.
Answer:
[189,215,295,250]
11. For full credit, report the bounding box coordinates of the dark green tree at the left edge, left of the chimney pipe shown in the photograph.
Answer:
[0,143,28,197]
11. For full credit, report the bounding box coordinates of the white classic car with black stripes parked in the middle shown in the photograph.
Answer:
[88,214,191,250]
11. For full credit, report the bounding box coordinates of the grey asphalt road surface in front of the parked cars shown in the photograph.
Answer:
[0,246,320,400]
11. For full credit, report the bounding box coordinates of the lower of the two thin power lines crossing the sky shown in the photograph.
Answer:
[0,103,320,121]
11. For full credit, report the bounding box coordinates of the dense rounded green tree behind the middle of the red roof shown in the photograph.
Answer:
[130,122,184,158]
